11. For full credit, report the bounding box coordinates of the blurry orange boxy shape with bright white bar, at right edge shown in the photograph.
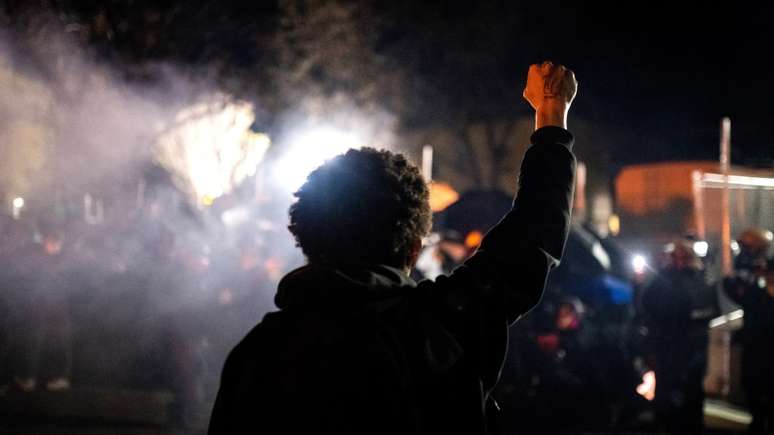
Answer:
[615,161,774,252]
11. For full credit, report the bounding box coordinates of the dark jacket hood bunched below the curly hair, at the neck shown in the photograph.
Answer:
[274,264,416,310]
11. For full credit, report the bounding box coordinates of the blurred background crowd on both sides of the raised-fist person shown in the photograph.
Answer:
[0,203,774,433]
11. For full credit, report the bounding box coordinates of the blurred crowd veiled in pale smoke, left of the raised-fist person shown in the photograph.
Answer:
[0,203,296,423]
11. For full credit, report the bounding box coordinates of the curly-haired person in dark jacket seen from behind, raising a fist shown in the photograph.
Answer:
[210,63,577,434]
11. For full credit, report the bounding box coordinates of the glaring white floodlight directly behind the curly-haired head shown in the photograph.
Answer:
[275,127,362,191]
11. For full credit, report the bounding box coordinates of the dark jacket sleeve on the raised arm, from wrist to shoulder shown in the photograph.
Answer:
[436,127,576,324]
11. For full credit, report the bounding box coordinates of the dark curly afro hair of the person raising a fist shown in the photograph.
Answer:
[288,148,431,268]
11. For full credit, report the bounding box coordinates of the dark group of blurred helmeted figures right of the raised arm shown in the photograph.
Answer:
[498,230,774,434]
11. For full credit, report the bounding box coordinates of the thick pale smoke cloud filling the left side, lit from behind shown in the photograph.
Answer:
[0,17,302,426]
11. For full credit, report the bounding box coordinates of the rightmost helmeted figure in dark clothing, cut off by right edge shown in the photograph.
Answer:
[723,230,774,435]
